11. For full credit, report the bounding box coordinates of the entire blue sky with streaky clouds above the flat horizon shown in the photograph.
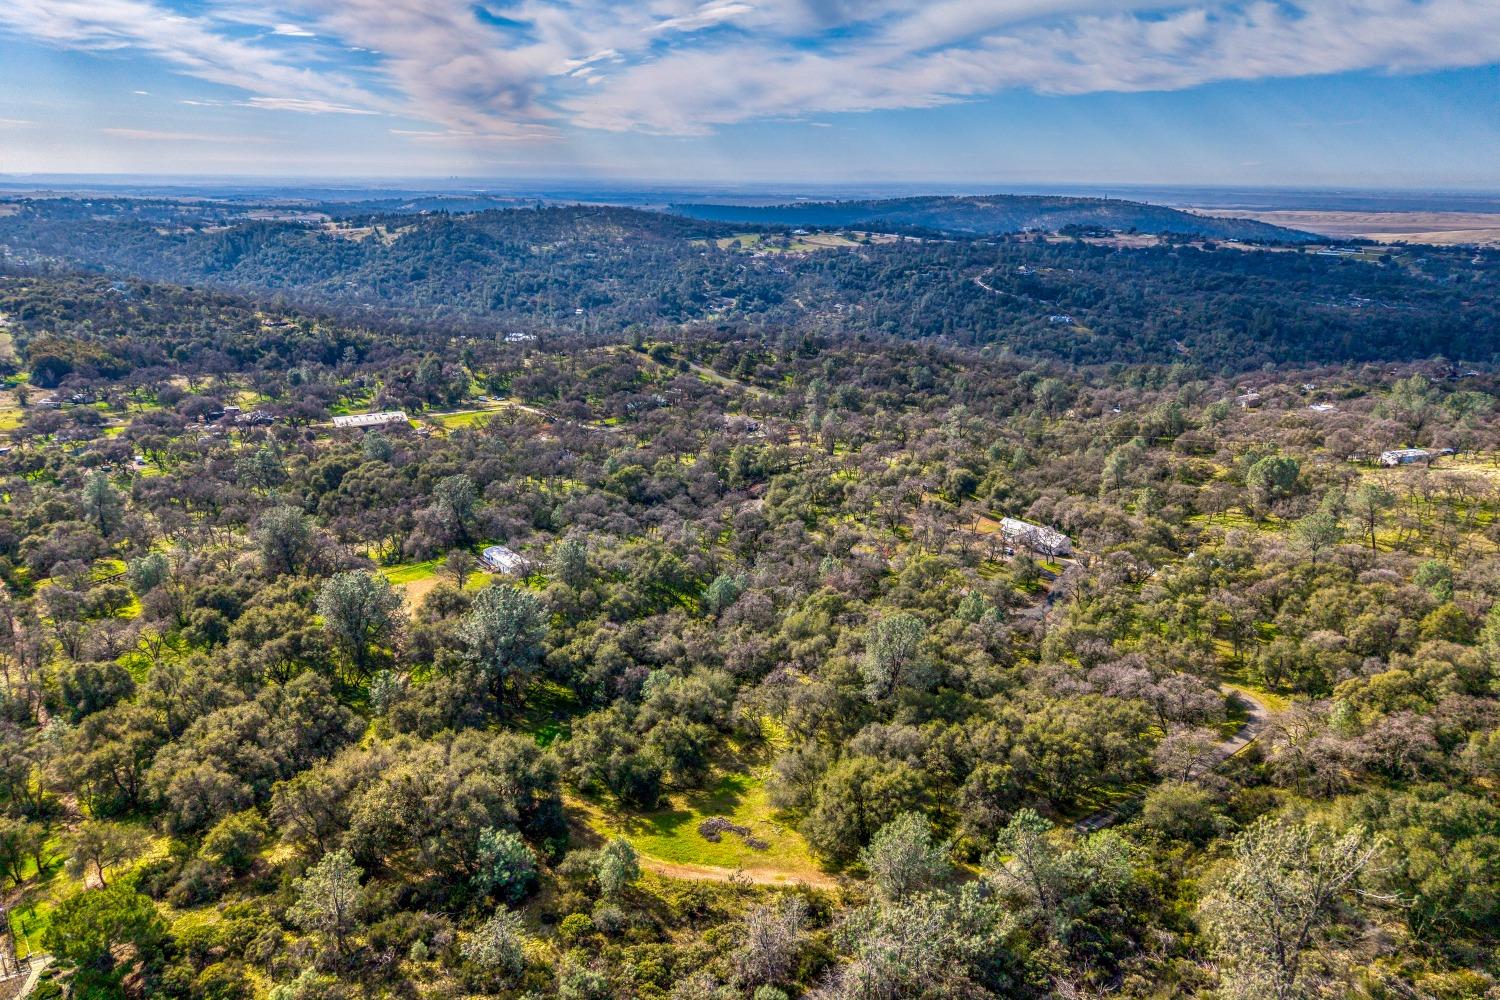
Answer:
[0,0,1500,190]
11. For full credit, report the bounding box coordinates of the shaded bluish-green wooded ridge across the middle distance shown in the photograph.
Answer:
[0,199,1500,375]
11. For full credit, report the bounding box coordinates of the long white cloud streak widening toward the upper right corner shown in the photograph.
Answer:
[566,0,1500,133]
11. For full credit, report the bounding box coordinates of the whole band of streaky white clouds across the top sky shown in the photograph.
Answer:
[0,0,1500,142]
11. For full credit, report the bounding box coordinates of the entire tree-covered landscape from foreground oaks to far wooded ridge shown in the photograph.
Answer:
[0,201,1500,1000]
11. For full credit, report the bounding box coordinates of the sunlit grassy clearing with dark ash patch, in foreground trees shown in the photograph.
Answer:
[585,772,819,874]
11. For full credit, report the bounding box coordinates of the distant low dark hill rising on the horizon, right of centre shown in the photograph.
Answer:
[671,195,1316,243]
